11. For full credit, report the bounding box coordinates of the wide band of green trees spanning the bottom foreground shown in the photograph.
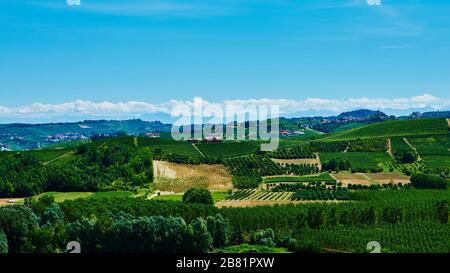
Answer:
[0,189,450,253]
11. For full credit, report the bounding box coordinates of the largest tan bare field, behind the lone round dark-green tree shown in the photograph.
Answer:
[153,160,233,192]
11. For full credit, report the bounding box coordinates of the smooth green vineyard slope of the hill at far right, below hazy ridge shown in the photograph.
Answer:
[323,118,449,141]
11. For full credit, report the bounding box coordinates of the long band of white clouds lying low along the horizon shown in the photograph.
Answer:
[0,94,450,119]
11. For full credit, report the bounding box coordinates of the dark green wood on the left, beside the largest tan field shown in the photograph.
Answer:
[0,145,153,197]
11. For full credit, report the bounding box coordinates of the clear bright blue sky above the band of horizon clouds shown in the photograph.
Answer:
[0,0,450,120]
